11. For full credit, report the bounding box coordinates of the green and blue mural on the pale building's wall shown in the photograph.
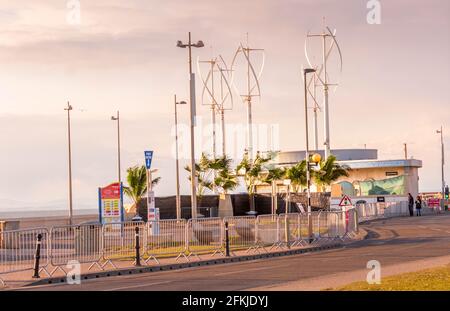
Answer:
[339,175,406,196]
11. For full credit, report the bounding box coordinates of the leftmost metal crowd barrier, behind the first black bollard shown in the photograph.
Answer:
[0,228,50,283]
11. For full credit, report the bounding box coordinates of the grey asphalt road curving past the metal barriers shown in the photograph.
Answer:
[18,213,450,291]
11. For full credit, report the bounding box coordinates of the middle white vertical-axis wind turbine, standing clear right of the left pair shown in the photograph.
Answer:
[231,33,265,160]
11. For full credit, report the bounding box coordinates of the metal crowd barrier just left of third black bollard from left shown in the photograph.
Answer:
[186,217,225,258]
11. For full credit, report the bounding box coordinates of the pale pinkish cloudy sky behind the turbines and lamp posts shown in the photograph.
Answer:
[0,0,450,210]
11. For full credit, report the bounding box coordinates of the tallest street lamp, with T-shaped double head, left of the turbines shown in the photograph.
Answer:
[177,32,205,218]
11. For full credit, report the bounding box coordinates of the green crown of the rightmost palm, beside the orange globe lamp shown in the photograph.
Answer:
[312,155,350,189]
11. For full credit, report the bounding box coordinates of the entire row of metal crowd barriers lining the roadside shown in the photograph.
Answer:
[0,202,442,283]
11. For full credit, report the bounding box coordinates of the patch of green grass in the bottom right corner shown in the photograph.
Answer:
[337,265,450,291]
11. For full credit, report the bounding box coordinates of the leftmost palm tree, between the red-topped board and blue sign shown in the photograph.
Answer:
[123,165,161,211]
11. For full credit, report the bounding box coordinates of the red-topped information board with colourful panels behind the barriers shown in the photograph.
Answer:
[98,183,124,224]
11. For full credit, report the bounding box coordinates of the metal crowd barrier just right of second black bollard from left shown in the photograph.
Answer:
[144,219,187,262]
